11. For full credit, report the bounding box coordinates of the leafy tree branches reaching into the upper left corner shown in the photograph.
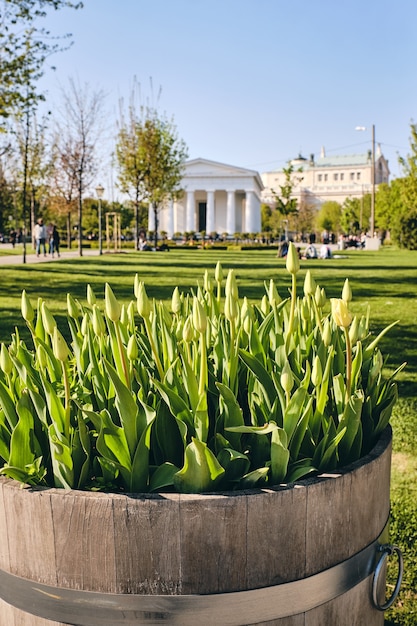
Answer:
[0,0,82,119]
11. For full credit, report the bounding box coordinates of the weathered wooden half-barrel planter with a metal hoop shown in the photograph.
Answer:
[0,428,391,626]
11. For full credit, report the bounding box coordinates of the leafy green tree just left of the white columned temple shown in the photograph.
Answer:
[116,101,188,248]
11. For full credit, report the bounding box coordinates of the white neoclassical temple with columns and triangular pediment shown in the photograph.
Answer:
[149,158,264,237]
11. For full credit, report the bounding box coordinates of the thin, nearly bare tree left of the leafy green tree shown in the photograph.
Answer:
[53,79,104,256]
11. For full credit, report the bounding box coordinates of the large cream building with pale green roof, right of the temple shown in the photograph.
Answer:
[261,145,390,207]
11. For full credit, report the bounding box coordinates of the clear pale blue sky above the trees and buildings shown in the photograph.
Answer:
[37,0,417,184]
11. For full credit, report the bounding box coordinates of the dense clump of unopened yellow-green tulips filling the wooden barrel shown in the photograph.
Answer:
[0,244,402,492]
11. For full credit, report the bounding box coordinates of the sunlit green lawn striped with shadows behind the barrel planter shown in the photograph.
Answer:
[0,243,417,626]
